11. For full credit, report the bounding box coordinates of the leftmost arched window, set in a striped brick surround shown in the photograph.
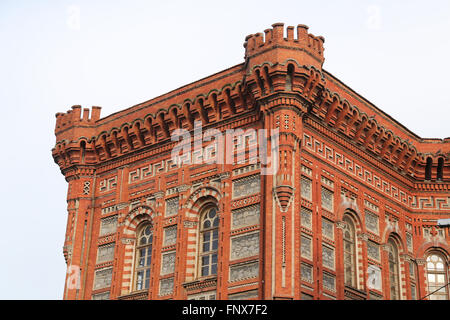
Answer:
[134,223,153,290]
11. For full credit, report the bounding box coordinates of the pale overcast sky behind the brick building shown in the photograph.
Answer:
[0,0,450,299]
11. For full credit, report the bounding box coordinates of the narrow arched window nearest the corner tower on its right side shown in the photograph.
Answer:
[343,216,356,287]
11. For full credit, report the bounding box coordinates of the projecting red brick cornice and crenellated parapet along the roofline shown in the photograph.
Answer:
[52,23,450,183]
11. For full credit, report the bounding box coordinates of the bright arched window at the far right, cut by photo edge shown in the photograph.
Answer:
[427,253,449,300]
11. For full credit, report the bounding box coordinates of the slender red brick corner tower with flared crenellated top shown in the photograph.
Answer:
[244,23,325,299]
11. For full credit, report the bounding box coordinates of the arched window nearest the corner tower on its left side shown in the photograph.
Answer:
[199,207,219,277]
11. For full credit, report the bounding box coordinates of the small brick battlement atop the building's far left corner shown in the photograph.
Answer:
[55,105,102,133]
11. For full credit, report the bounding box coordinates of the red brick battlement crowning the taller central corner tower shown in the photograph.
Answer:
[244,23,325,64]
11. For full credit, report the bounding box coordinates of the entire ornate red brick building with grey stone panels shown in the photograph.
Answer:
[52,23,450,299]
